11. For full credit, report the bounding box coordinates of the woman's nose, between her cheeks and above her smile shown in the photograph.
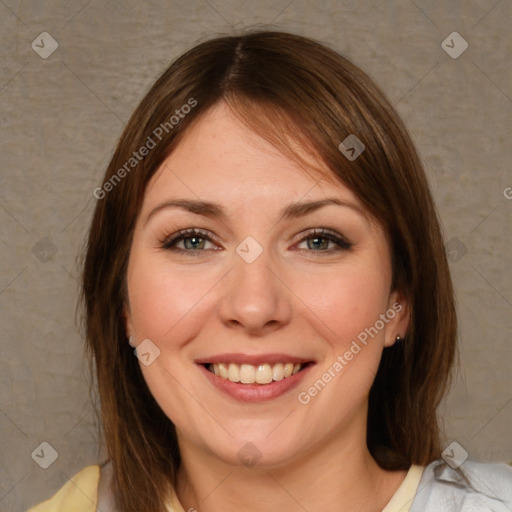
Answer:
[218,244,292,336]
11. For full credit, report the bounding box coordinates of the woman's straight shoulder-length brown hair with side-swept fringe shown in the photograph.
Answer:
[82,32,457,512]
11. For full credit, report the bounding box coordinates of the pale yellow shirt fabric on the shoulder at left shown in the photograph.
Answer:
[27,464,100,512]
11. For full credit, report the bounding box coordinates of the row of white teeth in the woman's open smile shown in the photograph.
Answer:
[208,363,303,384]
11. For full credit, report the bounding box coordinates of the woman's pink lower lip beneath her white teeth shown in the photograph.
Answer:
[198,363,314,402]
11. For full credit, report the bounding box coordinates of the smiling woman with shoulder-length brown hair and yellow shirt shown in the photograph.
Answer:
[28,32,512,512]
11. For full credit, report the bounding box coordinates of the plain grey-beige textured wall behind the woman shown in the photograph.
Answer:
[0,0,512,511]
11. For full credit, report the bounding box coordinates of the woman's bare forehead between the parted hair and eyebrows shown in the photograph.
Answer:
[146,103,363,215]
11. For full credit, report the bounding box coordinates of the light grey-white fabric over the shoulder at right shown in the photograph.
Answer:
[410,460,512,512]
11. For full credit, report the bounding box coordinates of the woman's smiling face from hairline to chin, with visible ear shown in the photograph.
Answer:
[126,103,407,465]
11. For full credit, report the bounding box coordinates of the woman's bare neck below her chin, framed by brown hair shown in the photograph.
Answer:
[176,416,406,512]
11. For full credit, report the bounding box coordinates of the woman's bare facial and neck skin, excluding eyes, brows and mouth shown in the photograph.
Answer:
[126,103,409,512]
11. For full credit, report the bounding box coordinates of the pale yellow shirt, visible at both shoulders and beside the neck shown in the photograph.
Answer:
[27,464,424,512]
